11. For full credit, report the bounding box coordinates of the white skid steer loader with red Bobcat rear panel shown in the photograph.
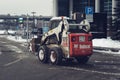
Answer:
[29,17,93,65]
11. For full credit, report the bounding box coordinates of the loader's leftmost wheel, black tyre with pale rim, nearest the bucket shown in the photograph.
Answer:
[38,46,48,63]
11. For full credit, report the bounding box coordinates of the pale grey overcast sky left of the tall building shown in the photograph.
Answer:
[0,0,53,16]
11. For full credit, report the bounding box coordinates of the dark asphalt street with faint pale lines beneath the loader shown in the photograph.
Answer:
[0,37,120,80]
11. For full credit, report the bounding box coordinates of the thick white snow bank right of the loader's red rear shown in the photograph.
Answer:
[93,38,120,48]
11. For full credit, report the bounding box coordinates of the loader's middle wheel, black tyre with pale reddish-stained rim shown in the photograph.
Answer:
[50,47,62,65]
